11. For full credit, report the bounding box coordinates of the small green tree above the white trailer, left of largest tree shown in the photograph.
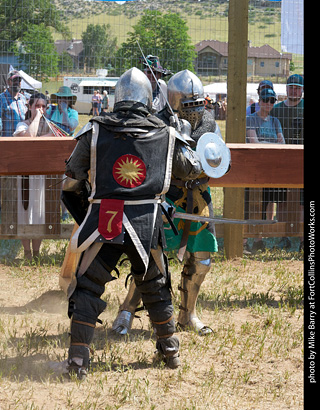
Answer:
[82,24,117,71]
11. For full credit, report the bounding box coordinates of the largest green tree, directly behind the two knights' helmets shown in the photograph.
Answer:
[117,10,196,74]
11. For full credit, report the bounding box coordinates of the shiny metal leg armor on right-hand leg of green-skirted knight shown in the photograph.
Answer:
[178,252,212,335]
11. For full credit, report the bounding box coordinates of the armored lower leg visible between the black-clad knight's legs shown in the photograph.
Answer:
[112,278,141,335]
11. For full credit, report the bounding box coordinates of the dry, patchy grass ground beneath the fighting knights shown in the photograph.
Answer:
[0,241,304,410]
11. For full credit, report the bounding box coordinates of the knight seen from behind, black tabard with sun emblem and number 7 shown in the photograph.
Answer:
[62,67,201,379]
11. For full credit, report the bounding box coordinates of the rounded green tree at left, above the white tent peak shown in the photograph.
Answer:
[13,24,59,79]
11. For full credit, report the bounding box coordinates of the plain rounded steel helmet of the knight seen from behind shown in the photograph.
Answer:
[114,67,152,109]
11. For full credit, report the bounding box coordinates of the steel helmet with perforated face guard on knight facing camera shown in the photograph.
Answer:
[168,70,205,130]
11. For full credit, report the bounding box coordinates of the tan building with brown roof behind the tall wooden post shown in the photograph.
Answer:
[195,40,292,78]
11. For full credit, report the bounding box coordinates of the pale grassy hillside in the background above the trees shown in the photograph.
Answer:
[55,0,281,51]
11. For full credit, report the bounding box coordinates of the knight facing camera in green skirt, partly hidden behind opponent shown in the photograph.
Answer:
[113,70,221,335]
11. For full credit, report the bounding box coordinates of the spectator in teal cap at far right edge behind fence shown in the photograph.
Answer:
[270,74,304,249]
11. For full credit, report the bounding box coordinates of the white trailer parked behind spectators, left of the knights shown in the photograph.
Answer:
[63,77,119,115]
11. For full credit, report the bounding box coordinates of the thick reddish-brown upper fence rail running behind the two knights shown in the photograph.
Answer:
[0,137,304,188]
